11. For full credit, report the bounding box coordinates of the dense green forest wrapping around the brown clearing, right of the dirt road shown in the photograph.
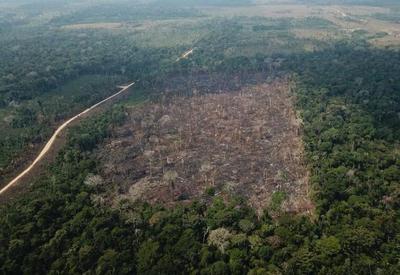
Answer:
[0,40,400,274]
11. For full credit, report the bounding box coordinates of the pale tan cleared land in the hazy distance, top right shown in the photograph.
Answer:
[201,1,400,46]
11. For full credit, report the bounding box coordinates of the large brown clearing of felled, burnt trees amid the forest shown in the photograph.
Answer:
[95,80,313,216]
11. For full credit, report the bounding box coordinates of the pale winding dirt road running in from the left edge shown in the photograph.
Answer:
[0,82,135,195]
